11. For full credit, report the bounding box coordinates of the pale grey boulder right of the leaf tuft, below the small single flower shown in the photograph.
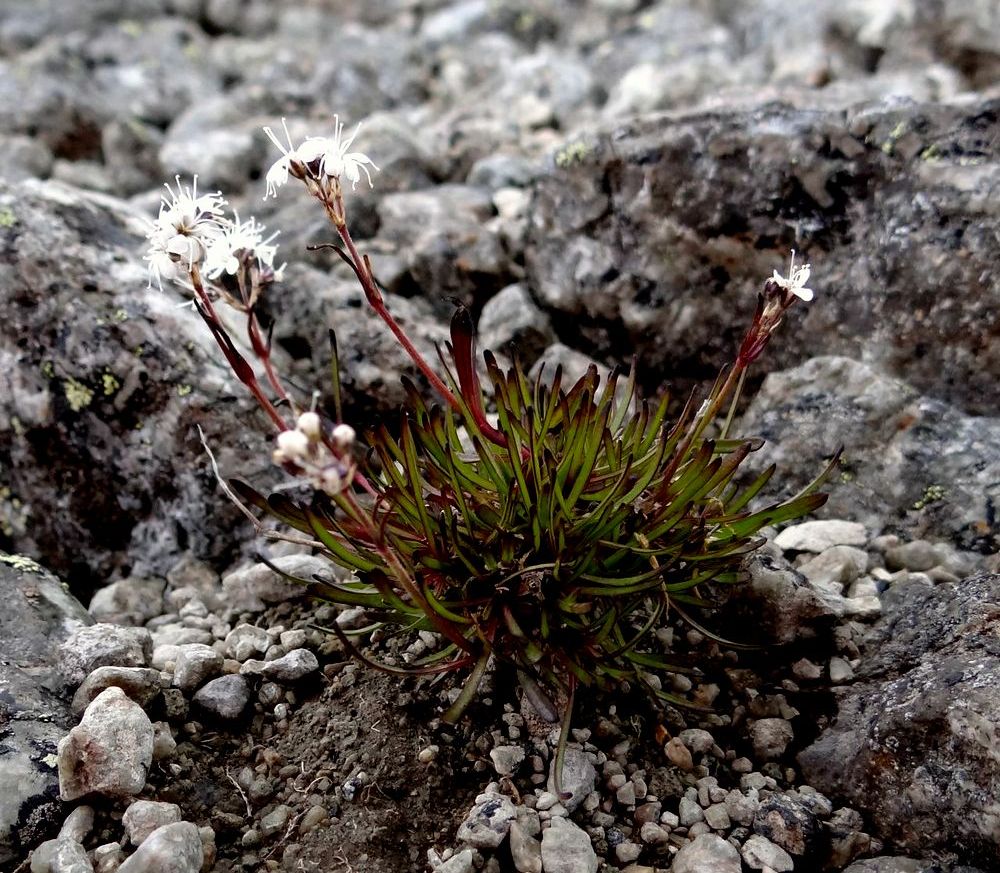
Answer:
[741,357,1000,554]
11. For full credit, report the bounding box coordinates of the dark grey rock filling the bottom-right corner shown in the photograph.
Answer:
[799,574,1000,867]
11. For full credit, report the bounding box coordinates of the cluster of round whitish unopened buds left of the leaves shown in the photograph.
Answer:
[272,412,355,497]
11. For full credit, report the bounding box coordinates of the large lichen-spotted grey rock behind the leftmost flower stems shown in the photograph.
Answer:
[0,180,266,596]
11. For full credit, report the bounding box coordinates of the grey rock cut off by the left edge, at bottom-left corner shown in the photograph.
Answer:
[0,552,92,865]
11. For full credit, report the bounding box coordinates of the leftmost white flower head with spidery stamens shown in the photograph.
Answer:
[144,176,226,290]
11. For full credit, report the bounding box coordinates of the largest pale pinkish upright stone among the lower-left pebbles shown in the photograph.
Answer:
[57,687,153,801]
